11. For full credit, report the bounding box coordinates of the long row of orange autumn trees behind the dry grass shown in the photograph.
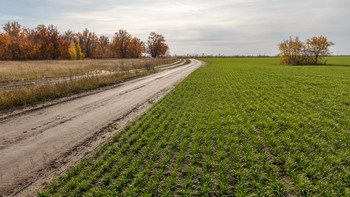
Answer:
[0,22,169,60]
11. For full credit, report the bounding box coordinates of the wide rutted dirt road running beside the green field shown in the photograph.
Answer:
[0,60,204,196]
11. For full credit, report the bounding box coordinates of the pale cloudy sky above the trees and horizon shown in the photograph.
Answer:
[0,0,350,55]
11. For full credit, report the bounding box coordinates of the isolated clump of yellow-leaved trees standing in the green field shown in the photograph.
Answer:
[279,36,334,65]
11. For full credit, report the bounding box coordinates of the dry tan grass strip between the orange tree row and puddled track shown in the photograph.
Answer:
[0,58,176,83]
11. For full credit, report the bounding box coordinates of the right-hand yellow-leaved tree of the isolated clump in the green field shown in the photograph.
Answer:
[306,36,334,64]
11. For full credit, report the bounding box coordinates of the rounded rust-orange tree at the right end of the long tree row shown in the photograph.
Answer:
[147,32,169,57]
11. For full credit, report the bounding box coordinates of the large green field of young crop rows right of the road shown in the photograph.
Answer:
[39,57,350,196]
